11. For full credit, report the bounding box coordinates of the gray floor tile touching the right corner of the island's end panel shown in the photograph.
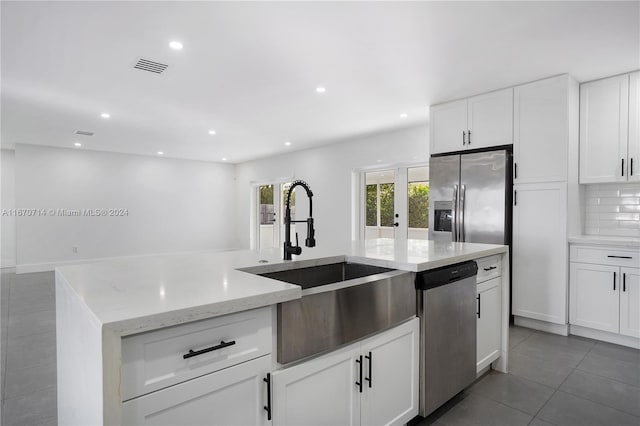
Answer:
[509,351,573,389]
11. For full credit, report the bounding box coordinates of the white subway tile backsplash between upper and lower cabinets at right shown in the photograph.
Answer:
[584,183,640,237]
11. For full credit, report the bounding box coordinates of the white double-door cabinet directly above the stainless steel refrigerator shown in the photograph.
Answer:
[430,88,513,154]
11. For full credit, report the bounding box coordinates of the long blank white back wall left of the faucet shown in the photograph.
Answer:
[15,145,236,272]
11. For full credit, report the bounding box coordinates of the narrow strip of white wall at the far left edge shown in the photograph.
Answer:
[0,149,16,268]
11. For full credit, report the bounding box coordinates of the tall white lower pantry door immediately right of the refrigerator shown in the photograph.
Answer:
[512,183,568,324]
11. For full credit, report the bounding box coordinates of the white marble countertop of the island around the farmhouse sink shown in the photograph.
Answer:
[56,239,508,336]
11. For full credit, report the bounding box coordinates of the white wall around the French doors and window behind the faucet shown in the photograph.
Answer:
[236,126,429,248]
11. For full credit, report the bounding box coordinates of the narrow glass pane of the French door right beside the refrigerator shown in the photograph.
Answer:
[407,166,429,240]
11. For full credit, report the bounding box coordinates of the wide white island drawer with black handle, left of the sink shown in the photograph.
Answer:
[121,307,272,401]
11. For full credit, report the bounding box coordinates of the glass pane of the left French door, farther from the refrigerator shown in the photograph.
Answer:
[365,170,395,239]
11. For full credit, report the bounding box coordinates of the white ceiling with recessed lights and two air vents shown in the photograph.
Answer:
[1,1,640,163]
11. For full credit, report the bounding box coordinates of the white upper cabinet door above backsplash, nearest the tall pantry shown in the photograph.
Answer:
[580,74,629,183]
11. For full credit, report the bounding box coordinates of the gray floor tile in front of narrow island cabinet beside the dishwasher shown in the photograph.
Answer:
[471,372,555,415]
